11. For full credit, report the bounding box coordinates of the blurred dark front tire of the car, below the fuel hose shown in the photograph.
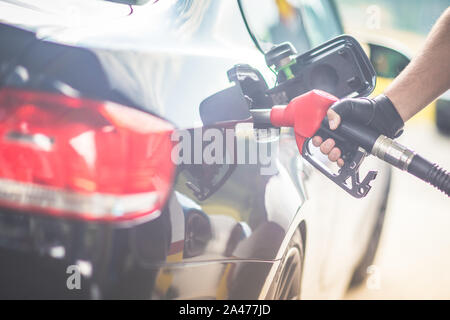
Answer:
[349,168,392,288]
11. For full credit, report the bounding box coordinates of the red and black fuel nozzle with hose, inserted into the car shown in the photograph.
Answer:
[250,90,450,198]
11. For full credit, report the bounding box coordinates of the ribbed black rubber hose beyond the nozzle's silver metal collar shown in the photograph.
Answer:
[407,154,450,196]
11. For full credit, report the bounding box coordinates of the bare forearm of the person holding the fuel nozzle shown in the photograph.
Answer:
[385,8,450,121]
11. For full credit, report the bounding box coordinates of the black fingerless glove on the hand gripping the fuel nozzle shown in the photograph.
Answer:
[332,94,404,139]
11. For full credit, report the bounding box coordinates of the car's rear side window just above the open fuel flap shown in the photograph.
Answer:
[240,0,342,53]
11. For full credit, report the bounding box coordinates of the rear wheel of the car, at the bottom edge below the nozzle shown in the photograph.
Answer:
[273,229,303,300]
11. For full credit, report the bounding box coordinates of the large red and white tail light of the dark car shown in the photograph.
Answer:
[0,88,175,221]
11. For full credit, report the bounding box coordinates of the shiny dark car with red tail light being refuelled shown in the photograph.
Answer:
[0,0,390,299]
